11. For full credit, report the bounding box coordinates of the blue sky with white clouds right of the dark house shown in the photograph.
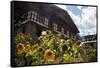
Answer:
[56,5,97,36]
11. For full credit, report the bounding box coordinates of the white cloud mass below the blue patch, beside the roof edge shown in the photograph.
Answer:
[67,6,96,36]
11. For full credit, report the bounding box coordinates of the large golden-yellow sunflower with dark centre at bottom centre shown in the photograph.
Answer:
[44,49,55,61]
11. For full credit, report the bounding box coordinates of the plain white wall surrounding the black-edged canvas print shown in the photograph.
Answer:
[0,0,100,68]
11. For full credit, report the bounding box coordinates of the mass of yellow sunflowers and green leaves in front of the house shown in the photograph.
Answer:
[15,30,96,66]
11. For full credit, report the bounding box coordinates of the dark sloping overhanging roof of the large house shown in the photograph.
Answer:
[14,1,79,33]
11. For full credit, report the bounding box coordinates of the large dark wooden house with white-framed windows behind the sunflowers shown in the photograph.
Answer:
[12,1,79,38]
